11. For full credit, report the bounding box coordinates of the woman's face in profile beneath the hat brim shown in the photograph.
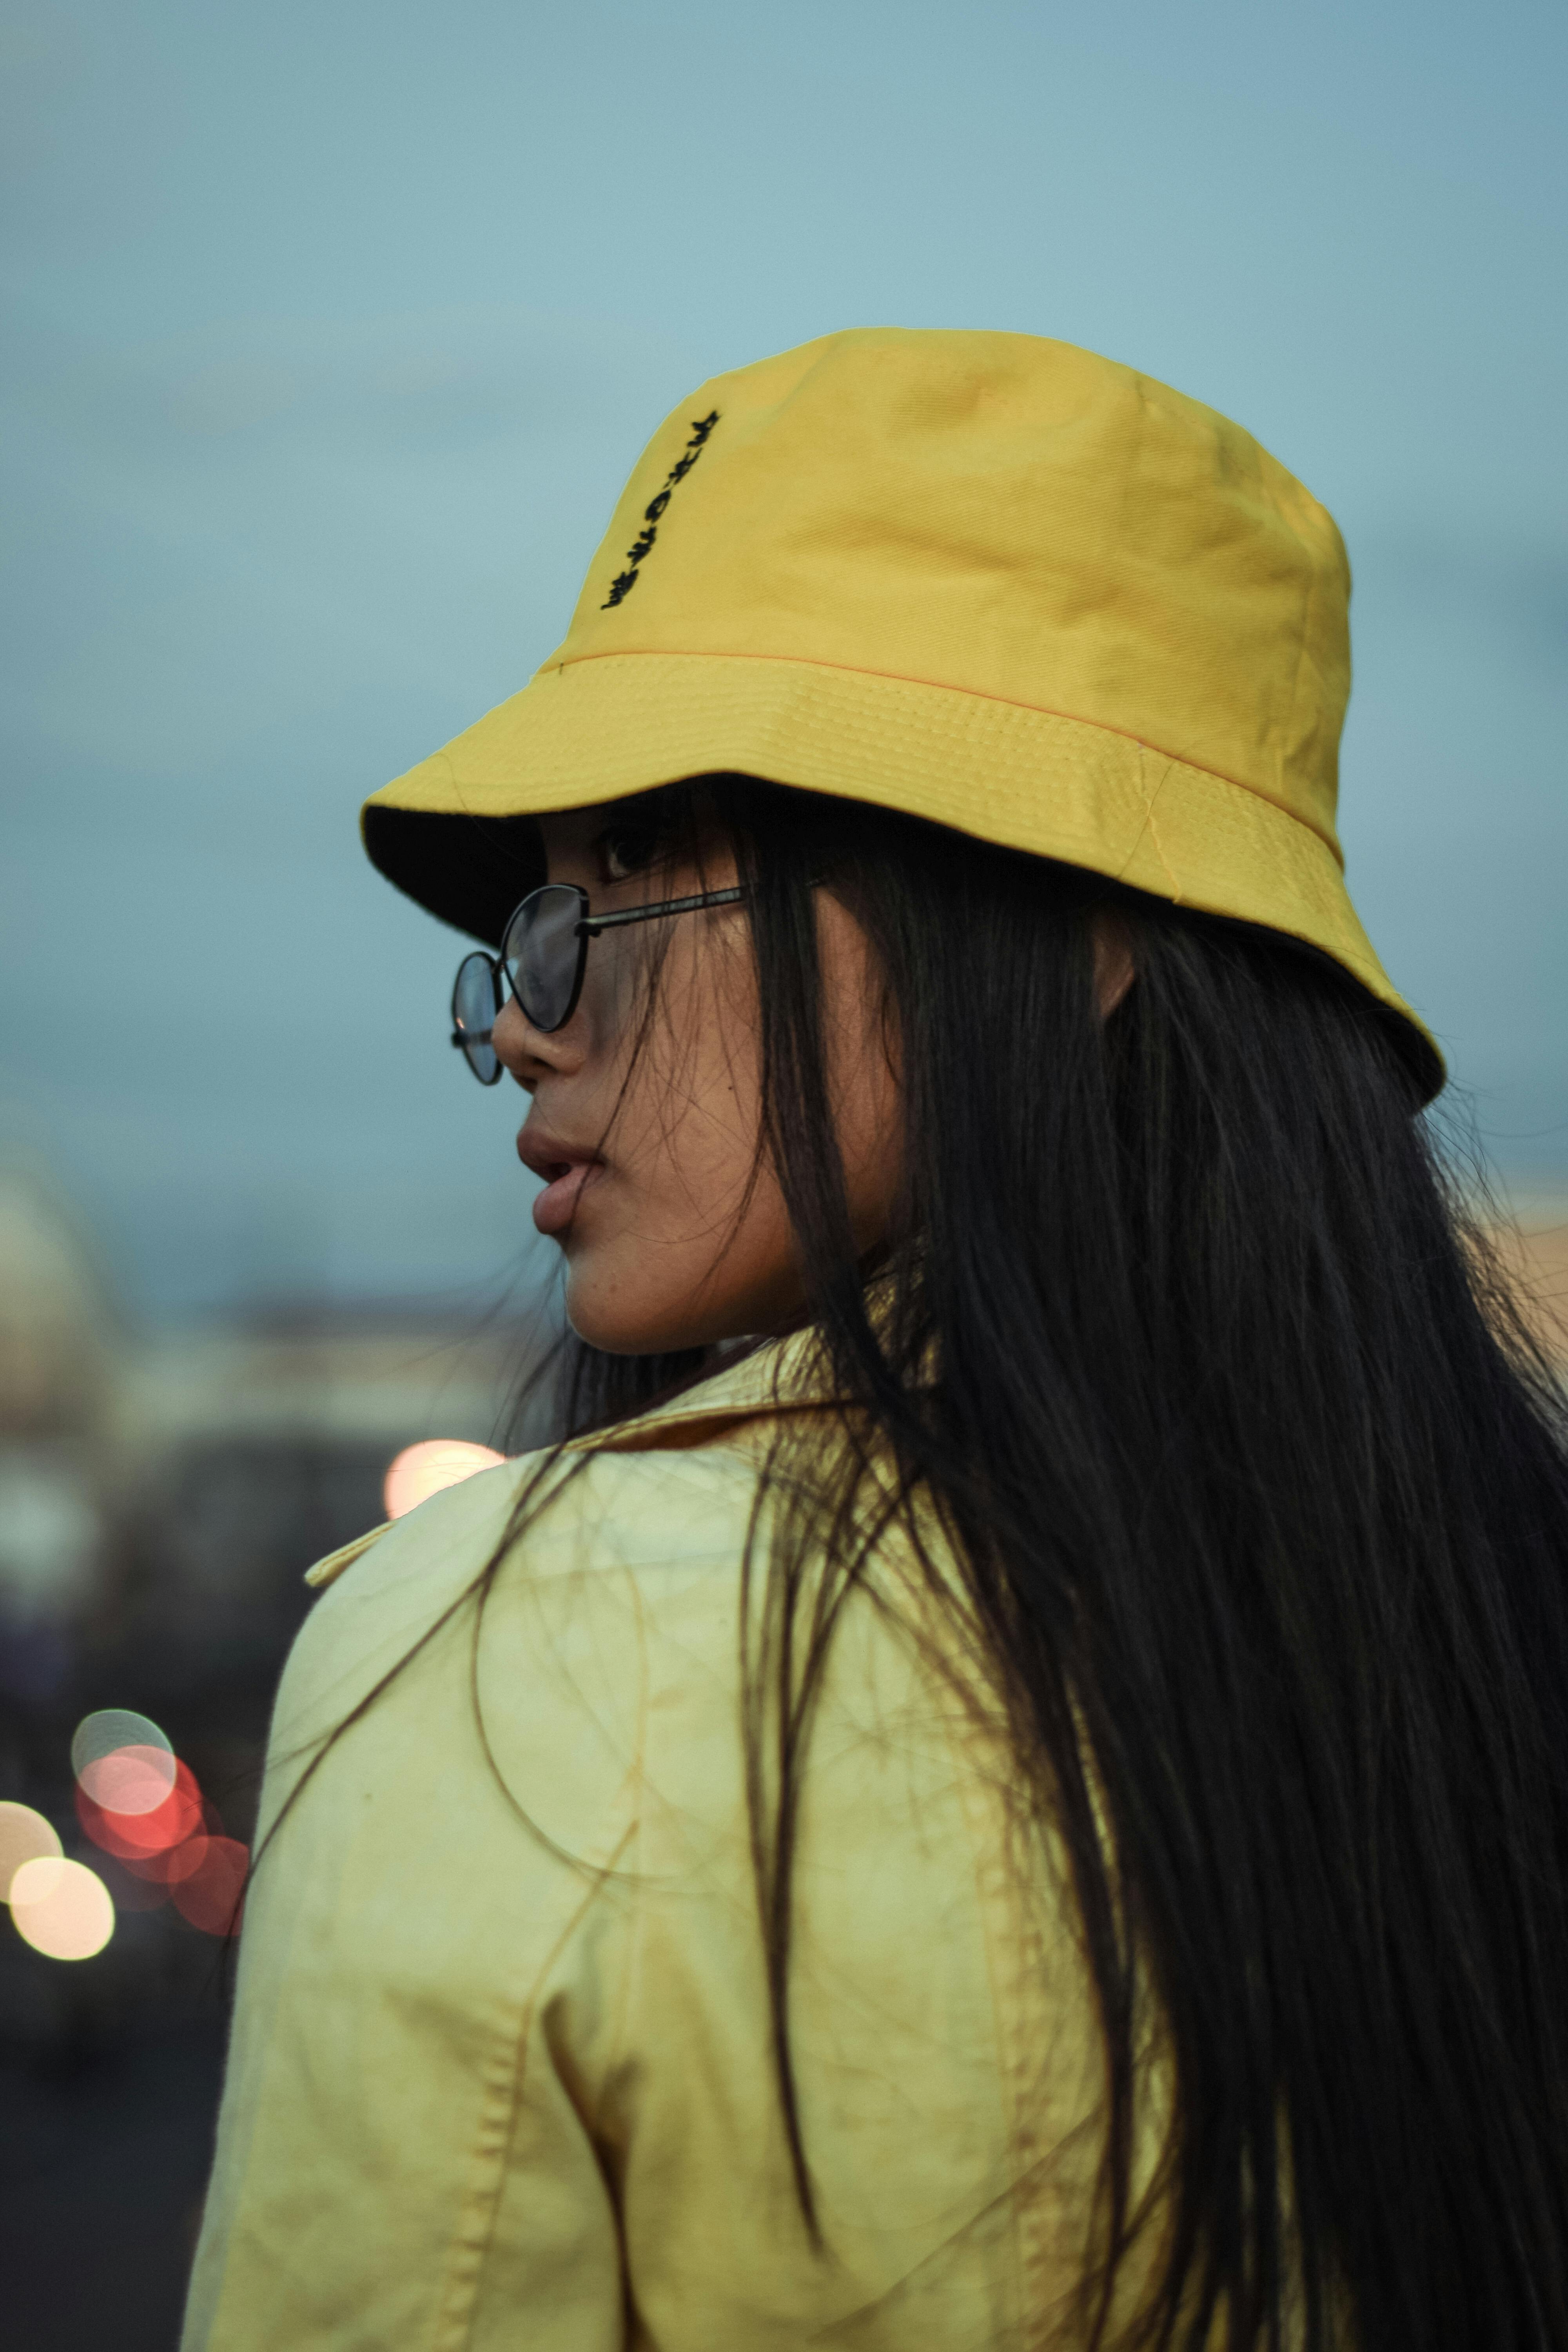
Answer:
[494,802,900,1355]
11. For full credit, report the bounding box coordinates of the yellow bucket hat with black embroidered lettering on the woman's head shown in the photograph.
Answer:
[362,327,1443,1091]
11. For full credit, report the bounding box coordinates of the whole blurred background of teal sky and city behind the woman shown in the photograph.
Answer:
[0,0,1568,2352]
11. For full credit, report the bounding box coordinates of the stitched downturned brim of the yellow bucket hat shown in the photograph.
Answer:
[362,654,1446,1101]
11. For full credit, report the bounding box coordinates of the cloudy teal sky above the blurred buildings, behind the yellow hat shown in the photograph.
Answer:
[0,0,1568,1312]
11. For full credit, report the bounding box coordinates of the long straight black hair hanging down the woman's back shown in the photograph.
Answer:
[536,776,1568,2352]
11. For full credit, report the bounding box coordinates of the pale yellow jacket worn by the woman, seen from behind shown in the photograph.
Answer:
[183,1338,1166,2352]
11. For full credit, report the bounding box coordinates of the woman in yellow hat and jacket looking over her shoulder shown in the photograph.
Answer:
[186,332,1568,2352]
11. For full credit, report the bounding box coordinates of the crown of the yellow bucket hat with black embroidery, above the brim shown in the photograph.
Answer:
[545,327,1349,856]
